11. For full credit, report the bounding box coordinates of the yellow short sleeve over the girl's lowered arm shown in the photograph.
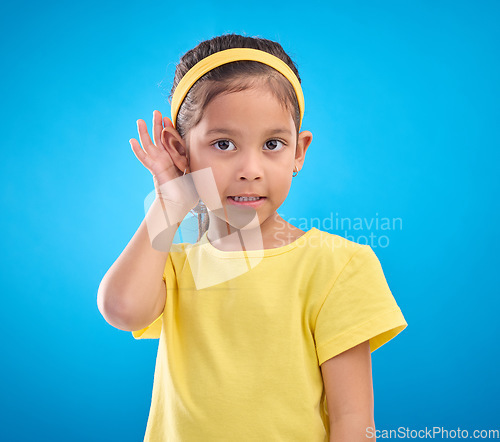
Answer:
[314,245,407,365]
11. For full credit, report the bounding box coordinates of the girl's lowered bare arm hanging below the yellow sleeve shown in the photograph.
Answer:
[321,341,375,442]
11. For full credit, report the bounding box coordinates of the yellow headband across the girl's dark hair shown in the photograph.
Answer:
[171,48,304,128]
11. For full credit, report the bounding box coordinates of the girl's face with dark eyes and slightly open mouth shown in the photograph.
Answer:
[186,86,312,233]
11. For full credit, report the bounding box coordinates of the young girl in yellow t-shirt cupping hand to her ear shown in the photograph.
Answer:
[98,34,407,442]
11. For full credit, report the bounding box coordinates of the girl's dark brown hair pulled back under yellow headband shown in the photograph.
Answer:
[169,34,301,240]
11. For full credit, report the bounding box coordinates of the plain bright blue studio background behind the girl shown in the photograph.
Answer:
[0,0,500,441]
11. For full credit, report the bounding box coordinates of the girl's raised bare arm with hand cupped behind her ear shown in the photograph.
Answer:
[97,111,199,331]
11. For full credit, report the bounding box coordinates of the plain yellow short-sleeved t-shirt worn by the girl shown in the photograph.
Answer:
[132,228,407,442]
